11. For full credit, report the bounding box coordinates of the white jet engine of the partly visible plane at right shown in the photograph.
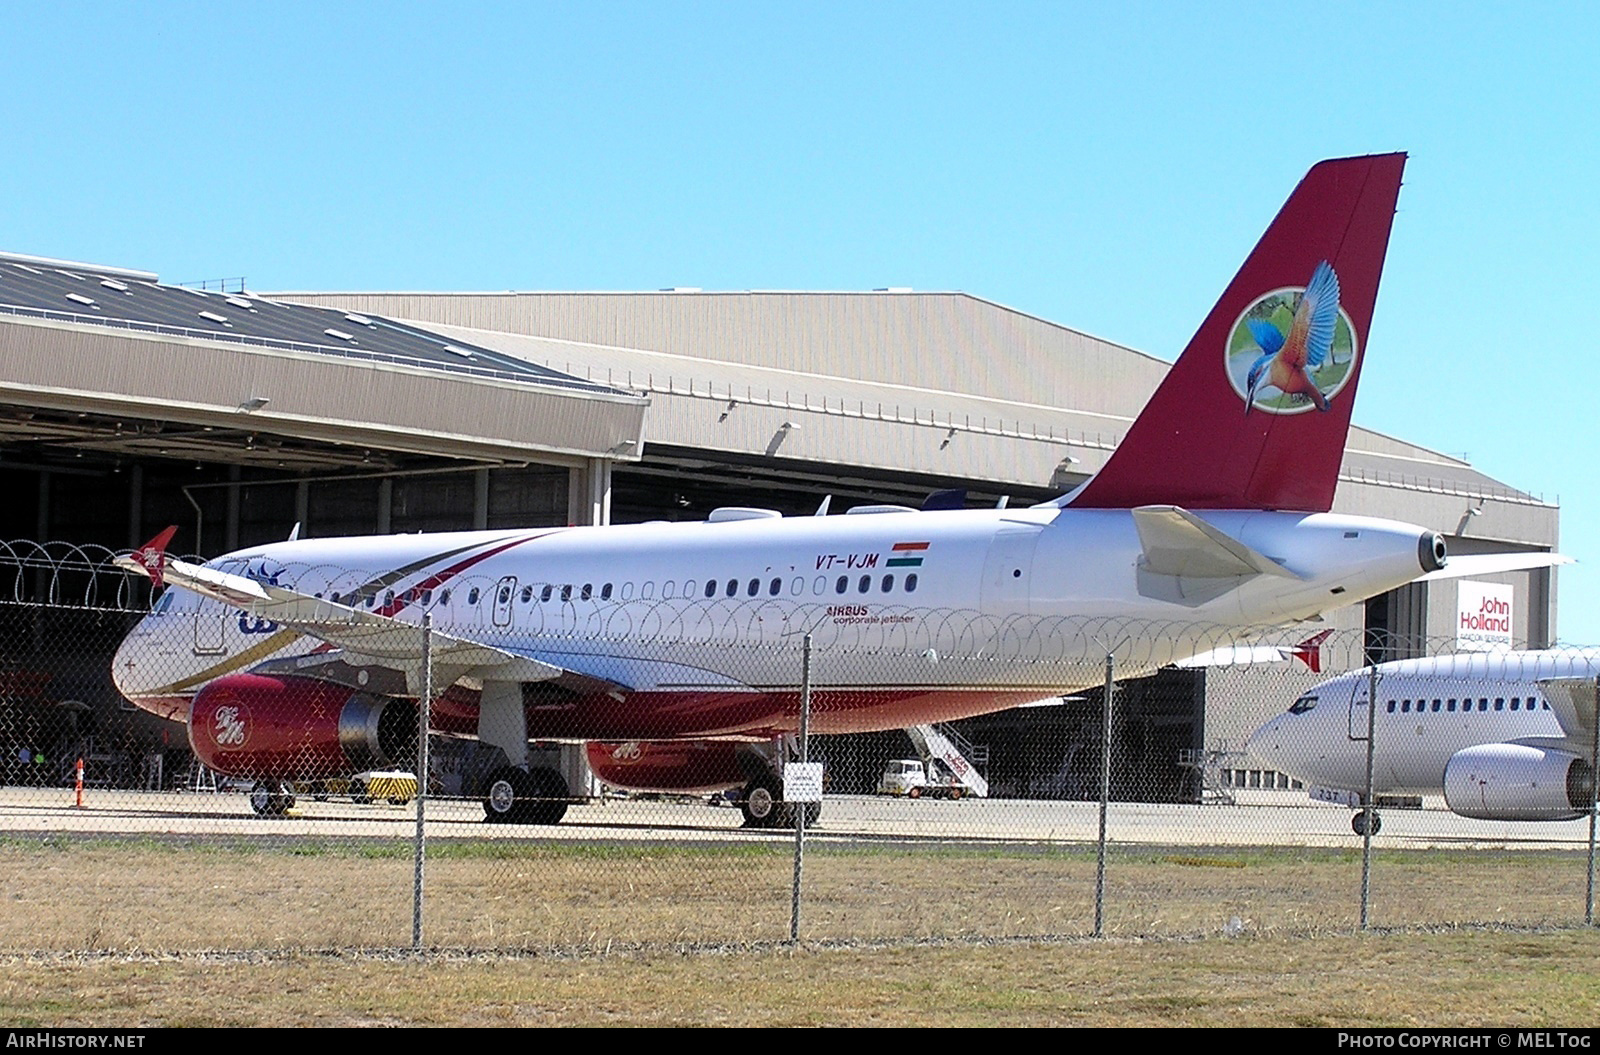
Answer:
[1445,743,1595,821]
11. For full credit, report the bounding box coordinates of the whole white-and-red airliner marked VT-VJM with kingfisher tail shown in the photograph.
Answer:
[115,154,1561,824]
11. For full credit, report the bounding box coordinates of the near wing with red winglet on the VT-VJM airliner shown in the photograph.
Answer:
[115,551,624,690]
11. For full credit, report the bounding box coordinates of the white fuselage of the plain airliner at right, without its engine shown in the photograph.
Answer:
[1246,650,1600,796]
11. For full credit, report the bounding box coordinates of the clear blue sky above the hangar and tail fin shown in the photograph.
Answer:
[0,2,1600,644]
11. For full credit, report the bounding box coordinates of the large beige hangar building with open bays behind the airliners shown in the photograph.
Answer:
[0,255,1558,797]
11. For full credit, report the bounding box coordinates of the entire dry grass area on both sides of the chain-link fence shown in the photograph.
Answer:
[0,836,1600,1026]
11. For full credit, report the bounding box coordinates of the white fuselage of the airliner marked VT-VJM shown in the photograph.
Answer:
[115,506,1429,735]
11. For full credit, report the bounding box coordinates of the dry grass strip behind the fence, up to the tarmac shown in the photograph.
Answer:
[0,836,1587,953]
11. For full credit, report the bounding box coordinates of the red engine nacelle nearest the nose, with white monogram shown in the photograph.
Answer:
[189,674,416,780]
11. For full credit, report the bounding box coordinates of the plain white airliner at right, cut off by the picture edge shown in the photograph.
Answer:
[1246,648,1600,834]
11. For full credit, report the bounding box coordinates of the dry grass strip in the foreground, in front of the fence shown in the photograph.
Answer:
[0,930,1600,1028]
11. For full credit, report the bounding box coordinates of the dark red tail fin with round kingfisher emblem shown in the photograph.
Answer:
[1067,154,1405,512]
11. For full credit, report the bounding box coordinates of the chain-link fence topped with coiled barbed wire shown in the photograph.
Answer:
[0,544,1600,951]
